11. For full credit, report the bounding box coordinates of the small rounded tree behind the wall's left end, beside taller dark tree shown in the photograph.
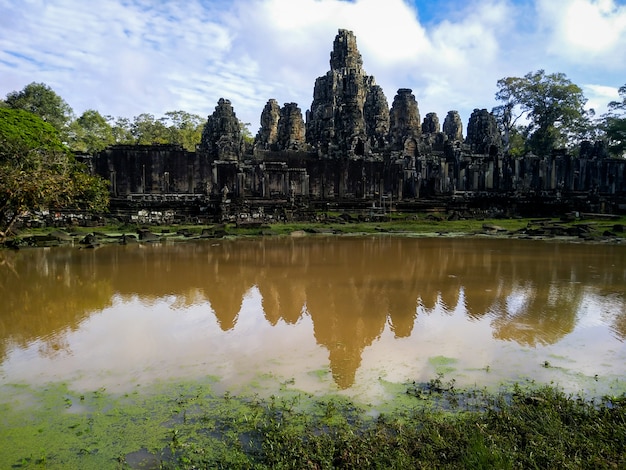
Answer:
[69,109,115,155]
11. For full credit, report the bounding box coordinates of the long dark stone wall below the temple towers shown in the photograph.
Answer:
[93,141,626,211]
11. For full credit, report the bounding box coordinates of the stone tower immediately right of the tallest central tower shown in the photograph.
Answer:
[389,88,421,156]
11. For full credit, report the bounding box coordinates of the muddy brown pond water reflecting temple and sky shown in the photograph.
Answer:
[0,236,626,400]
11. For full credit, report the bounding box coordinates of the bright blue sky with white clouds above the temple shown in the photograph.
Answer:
[0,0,626,133]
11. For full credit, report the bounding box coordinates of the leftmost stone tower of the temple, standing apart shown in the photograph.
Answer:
[199,98,243,161]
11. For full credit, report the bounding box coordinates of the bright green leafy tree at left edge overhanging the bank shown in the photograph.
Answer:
[0,108,108,238]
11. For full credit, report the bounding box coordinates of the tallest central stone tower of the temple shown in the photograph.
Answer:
[306,29,388,158]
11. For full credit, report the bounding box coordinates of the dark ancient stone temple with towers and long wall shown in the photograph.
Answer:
[89,29,626,220]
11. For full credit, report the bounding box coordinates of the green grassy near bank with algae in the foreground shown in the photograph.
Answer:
[0,377,626,469]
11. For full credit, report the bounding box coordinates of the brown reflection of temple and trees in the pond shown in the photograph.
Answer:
[0,236,626,388]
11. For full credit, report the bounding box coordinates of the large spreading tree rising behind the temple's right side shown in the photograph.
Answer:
[496,70,587,155]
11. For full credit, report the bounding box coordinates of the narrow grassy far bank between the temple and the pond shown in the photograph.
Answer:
[0,213,626,249]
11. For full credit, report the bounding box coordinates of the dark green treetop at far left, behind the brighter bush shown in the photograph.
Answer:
[6,82,73,137]
